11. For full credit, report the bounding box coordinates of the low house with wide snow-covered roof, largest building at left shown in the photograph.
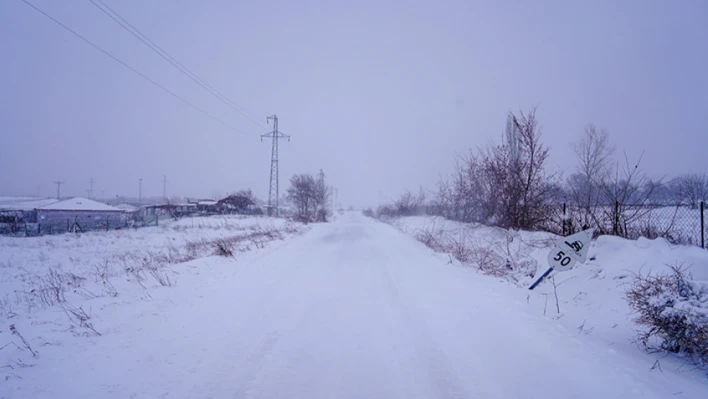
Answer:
[36,197,126,232]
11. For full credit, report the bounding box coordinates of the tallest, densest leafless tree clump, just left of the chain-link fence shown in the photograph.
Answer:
[438,109,557,229]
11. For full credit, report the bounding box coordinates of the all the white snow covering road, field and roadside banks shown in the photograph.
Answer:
[0,213,708,399]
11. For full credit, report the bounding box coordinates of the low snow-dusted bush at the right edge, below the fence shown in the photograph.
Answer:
[626,266,708,366]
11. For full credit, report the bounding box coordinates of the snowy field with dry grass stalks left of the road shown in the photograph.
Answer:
[0,216,306,397]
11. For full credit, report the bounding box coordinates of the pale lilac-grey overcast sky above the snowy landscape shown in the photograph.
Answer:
[0,0,708,205]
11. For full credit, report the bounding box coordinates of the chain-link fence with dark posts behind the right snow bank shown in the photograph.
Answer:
[548,202,708,248]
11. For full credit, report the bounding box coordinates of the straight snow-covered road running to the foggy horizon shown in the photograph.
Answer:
[6,214,706,399]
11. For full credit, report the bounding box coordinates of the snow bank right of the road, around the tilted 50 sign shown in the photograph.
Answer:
[390,216,708,367]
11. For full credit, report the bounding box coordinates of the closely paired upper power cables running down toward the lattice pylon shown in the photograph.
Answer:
[88,0,264,127]
